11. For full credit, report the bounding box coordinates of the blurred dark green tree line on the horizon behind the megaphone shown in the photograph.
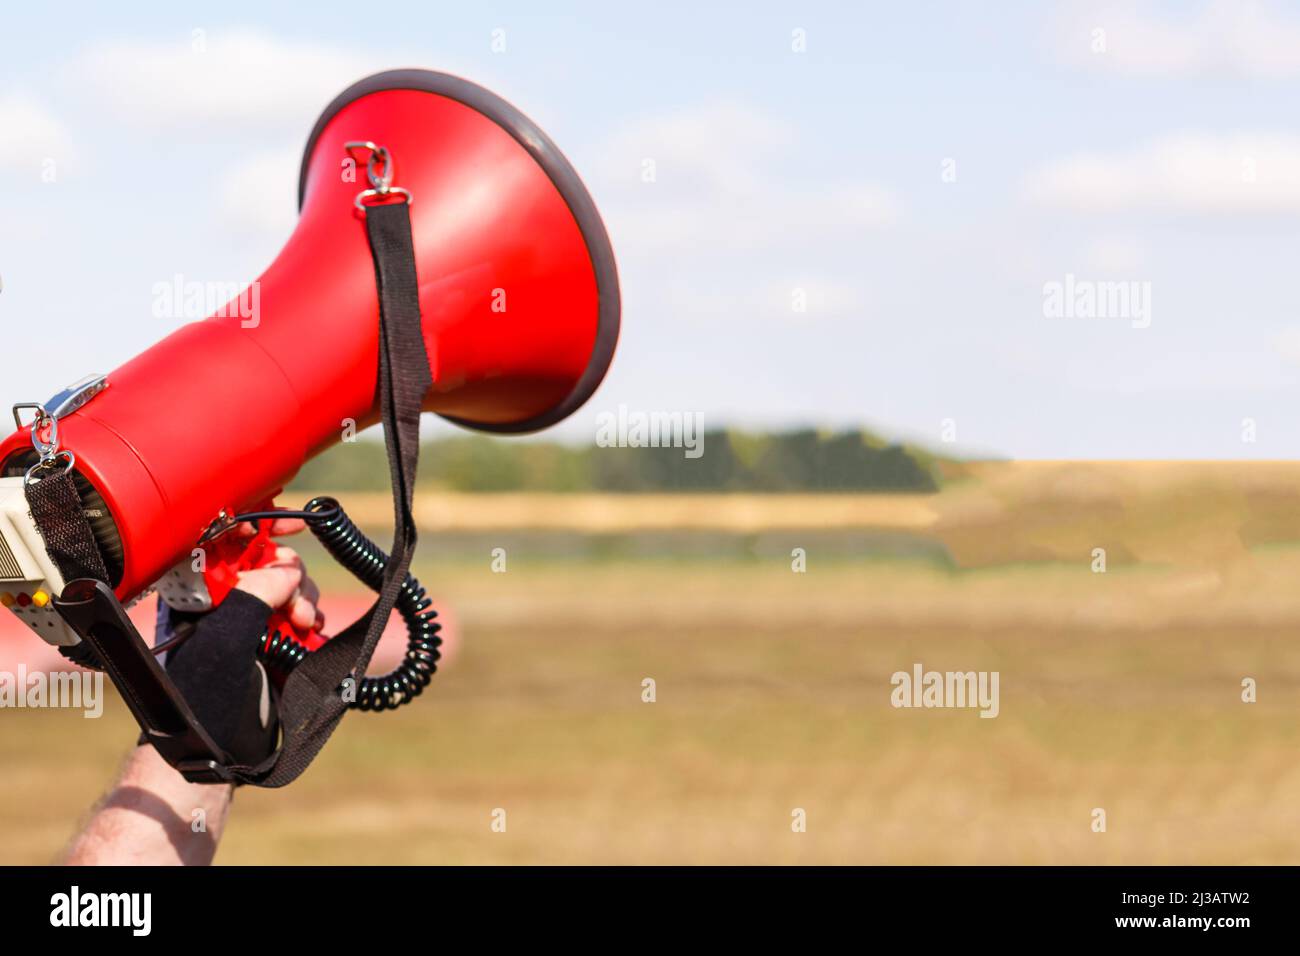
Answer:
[294,428,937,492]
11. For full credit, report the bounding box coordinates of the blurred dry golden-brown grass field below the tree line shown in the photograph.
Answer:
[0,463,1300,864]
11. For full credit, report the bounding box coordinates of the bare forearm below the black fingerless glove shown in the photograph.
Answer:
[66,747,231,866]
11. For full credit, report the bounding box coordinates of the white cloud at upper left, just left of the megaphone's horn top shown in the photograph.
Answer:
[69,30,382,135]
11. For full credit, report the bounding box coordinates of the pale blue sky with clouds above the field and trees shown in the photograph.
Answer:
[0,1,1300,458]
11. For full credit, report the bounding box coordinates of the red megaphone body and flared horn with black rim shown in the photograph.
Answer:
[0,70,619,624]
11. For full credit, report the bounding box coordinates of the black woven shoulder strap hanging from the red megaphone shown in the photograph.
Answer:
[35,202,433,787]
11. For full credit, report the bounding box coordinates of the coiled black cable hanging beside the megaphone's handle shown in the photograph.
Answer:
[256,497,442,710]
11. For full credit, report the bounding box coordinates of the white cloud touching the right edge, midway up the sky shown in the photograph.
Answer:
[1024,133,1300,215]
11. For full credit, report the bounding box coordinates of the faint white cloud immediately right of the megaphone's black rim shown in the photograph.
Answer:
[601,103,902,255]
